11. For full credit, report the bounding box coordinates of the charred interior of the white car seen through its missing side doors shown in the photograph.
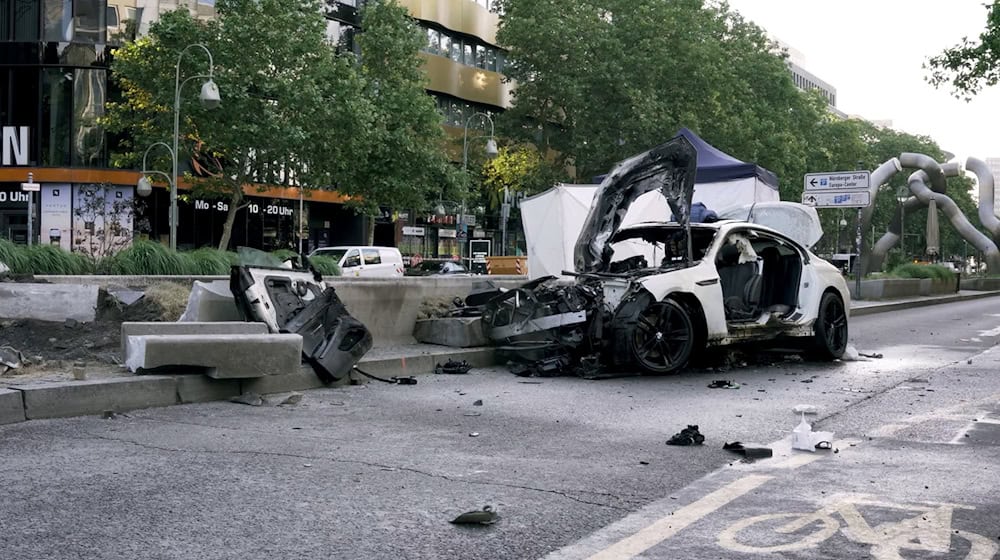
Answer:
[716,232,802,322]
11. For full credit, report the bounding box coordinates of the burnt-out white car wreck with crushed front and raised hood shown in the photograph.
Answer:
[483,137,850,376]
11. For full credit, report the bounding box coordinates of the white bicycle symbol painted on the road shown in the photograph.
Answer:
[718,494,1000,560]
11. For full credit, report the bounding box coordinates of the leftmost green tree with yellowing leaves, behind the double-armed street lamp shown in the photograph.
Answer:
[102,0,372,248]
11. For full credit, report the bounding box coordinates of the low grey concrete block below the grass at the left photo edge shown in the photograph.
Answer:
[0,282,98,323]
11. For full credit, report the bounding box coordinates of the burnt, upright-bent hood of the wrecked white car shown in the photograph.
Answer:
[573,136,698,274]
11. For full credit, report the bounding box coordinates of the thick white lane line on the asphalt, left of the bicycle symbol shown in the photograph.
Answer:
[590,475,774,560]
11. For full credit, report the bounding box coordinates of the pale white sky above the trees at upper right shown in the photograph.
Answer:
[729,0,1000,164]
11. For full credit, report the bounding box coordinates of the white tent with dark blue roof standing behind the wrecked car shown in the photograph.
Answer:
[520,128,779,279]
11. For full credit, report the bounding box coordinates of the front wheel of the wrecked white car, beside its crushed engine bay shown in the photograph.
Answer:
[628,299,695,375]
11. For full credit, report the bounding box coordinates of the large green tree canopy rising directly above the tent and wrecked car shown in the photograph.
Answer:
[497,0,825,194]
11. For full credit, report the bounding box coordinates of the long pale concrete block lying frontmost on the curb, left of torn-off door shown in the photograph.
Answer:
[125,334,302,379]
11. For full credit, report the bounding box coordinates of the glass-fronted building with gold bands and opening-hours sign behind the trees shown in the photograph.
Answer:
[0,0,510,256]
